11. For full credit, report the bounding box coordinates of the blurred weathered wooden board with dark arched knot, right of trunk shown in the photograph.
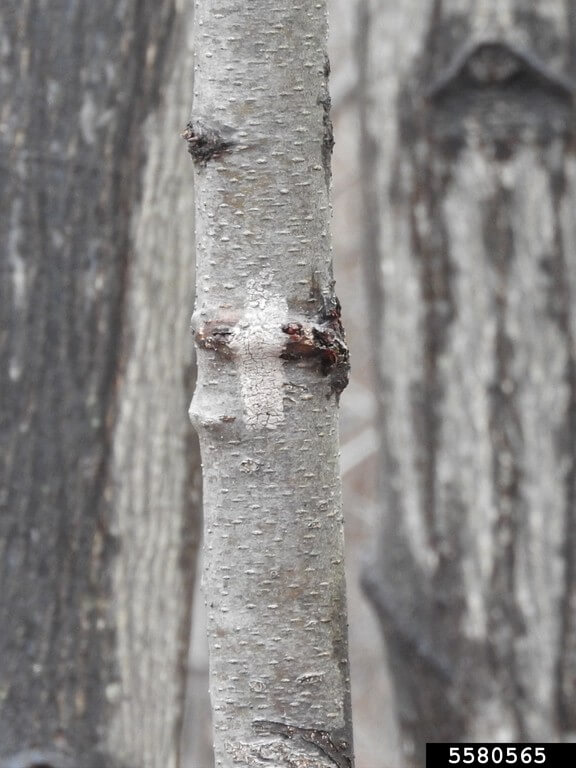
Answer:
[359,0,576,761]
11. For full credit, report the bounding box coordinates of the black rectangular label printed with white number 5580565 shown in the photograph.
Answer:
[426,744,576,768]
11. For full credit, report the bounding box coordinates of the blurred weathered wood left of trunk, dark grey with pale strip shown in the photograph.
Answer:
[0,2,199,768]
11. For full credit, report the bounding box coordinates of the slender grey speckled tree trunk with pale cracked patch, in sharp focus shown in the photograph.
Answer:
[184,0,352,768]
